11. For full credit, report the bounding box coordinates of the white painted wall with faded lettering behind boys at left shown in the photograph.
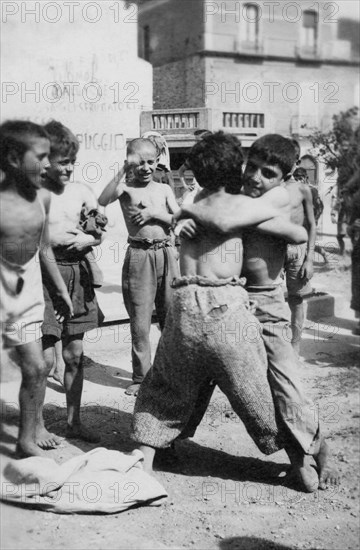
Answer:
[0,0,152,318]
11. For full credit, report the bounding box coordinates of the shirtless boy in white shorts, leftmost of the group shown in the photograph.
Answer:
[0,120,73,457]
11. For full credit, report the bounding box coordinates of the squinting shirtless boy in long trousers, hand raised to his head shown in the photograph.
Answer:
[99,138,179,395]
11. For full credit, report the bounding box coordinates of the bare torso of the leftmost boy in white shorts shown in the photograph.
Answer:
[0,186,48,265]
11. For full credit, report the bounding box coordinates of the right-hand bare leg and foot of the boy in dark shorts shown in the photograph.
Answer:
[63,334,100,443]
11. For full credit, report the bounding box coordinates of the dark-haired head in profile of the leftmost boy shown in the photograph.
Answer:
[0,120,50,191]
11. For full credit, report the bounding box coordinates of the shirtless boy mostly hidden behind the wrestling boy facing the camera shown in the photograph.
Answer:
[286,142,316,355]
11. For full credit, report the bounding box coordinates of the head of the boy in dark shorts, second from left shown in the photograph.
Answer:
[44,120,79,194]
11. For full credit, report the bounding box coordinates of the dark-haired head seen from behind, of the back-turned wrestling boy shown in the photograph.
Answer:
[188,132,244,193]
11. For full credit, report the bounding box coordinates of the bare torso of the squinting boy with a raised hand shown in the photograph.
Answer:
[119,181,169,239]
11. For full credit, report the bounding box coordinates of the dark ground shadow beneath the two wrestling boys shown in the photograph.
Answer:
[154,440,290,485]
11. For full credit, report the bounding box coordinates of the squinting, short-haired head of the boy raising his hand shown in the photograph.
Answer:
[126,138,158,186]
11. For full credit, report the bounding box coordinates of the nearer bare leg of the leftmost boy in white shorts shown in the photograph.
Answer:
[16,342,47,458]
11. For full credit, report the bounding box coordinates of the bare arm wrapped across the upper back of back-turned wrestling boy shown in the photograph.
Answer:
[174,187,289,233]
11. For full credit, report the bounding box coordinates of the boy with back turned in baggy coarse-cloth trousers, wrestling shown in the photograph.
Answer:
[133,132,312,484]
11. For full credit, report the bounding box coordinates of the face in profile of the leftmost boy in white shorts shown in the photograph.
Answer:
[16,138,50,189]
